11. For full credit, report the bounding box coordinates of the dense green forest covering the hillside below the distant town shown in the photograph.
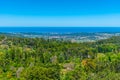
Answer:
[0,35,120,80]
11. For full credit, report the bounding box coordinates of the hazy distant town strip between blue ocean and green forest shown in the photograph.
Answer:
[1,32,120,42]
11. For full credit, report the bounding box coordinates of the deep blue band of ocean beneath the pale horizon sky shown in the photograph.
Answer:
[0,27,120,33]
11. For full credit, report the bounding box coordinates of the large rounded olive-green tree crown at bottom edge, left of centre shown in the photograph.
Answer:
[22,66,60,80]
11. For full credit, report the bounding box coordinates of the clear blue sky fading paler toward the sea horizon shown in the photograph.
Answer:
[0,0,120,27]
